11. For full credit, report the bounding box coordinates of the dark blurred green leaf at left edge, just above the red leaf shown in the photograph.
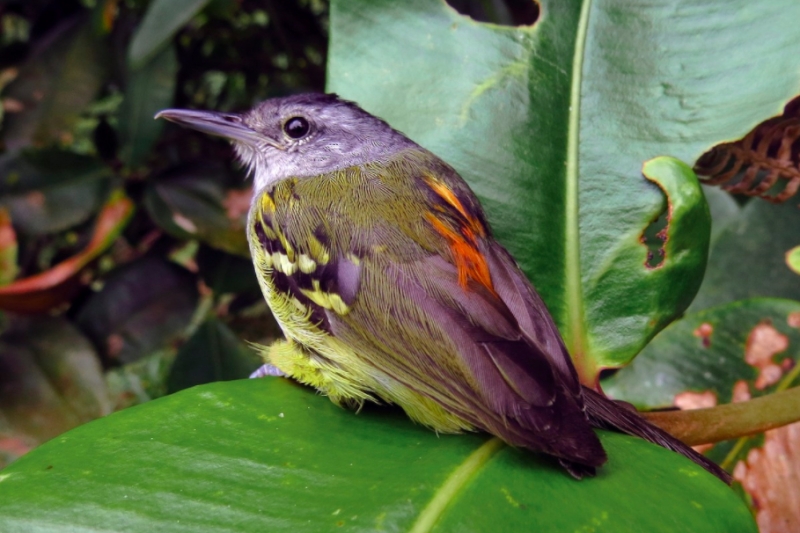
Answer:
[0,149,111,235]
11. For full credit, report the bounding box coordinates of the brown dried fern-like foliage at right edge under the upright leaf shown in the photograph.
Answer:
[694,96,800,203]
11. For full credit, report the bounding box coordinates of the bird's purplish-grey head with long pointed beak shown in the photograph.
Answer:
[156,94,416,190]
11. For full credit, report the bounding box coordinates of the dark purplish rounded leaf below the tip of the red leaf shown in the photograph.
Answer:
[76,257,198,363]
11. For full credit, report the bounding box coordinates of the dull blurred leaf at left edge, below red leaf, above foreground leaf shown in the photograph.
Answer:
[0,317,111,466]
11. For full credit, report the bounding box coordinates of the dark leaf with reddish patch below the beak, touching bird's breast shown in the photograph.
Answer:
[144,166,250,258]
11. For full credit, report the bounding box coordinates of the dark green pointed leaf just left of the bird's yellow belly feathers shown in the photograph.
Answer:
[167,318,260,392]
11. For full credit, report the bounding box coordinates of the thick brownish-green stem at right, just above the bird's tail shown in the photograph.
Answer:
[642,386,800,446]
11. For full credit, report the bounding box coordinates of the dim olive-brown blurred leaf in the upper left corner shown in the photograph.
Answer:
[2,18,109,150]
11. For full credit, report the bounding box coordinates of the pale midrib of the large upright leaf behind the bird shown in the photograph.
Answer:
[564,0,594,383]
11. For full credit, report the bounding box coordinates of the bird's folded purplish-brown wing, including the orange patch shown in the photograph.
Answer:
[328,167,605,465]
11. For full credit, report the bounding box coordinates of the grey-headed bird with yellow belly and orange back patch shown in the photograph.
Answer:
[156,93,730,483]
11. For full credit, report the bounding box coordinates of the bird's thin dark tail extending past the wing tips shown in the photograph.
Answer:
[583,387,731,485]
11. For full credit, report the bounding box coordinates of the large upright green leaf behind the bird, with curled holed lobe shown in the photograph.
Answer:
[328,0,800,379]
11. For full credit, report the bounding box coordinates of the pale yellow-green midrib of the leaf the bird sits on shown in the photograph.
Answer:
[408,437,505,533]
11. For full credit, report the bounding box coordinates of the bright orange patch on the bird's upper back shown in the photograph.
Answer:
[425,176,497,296]
